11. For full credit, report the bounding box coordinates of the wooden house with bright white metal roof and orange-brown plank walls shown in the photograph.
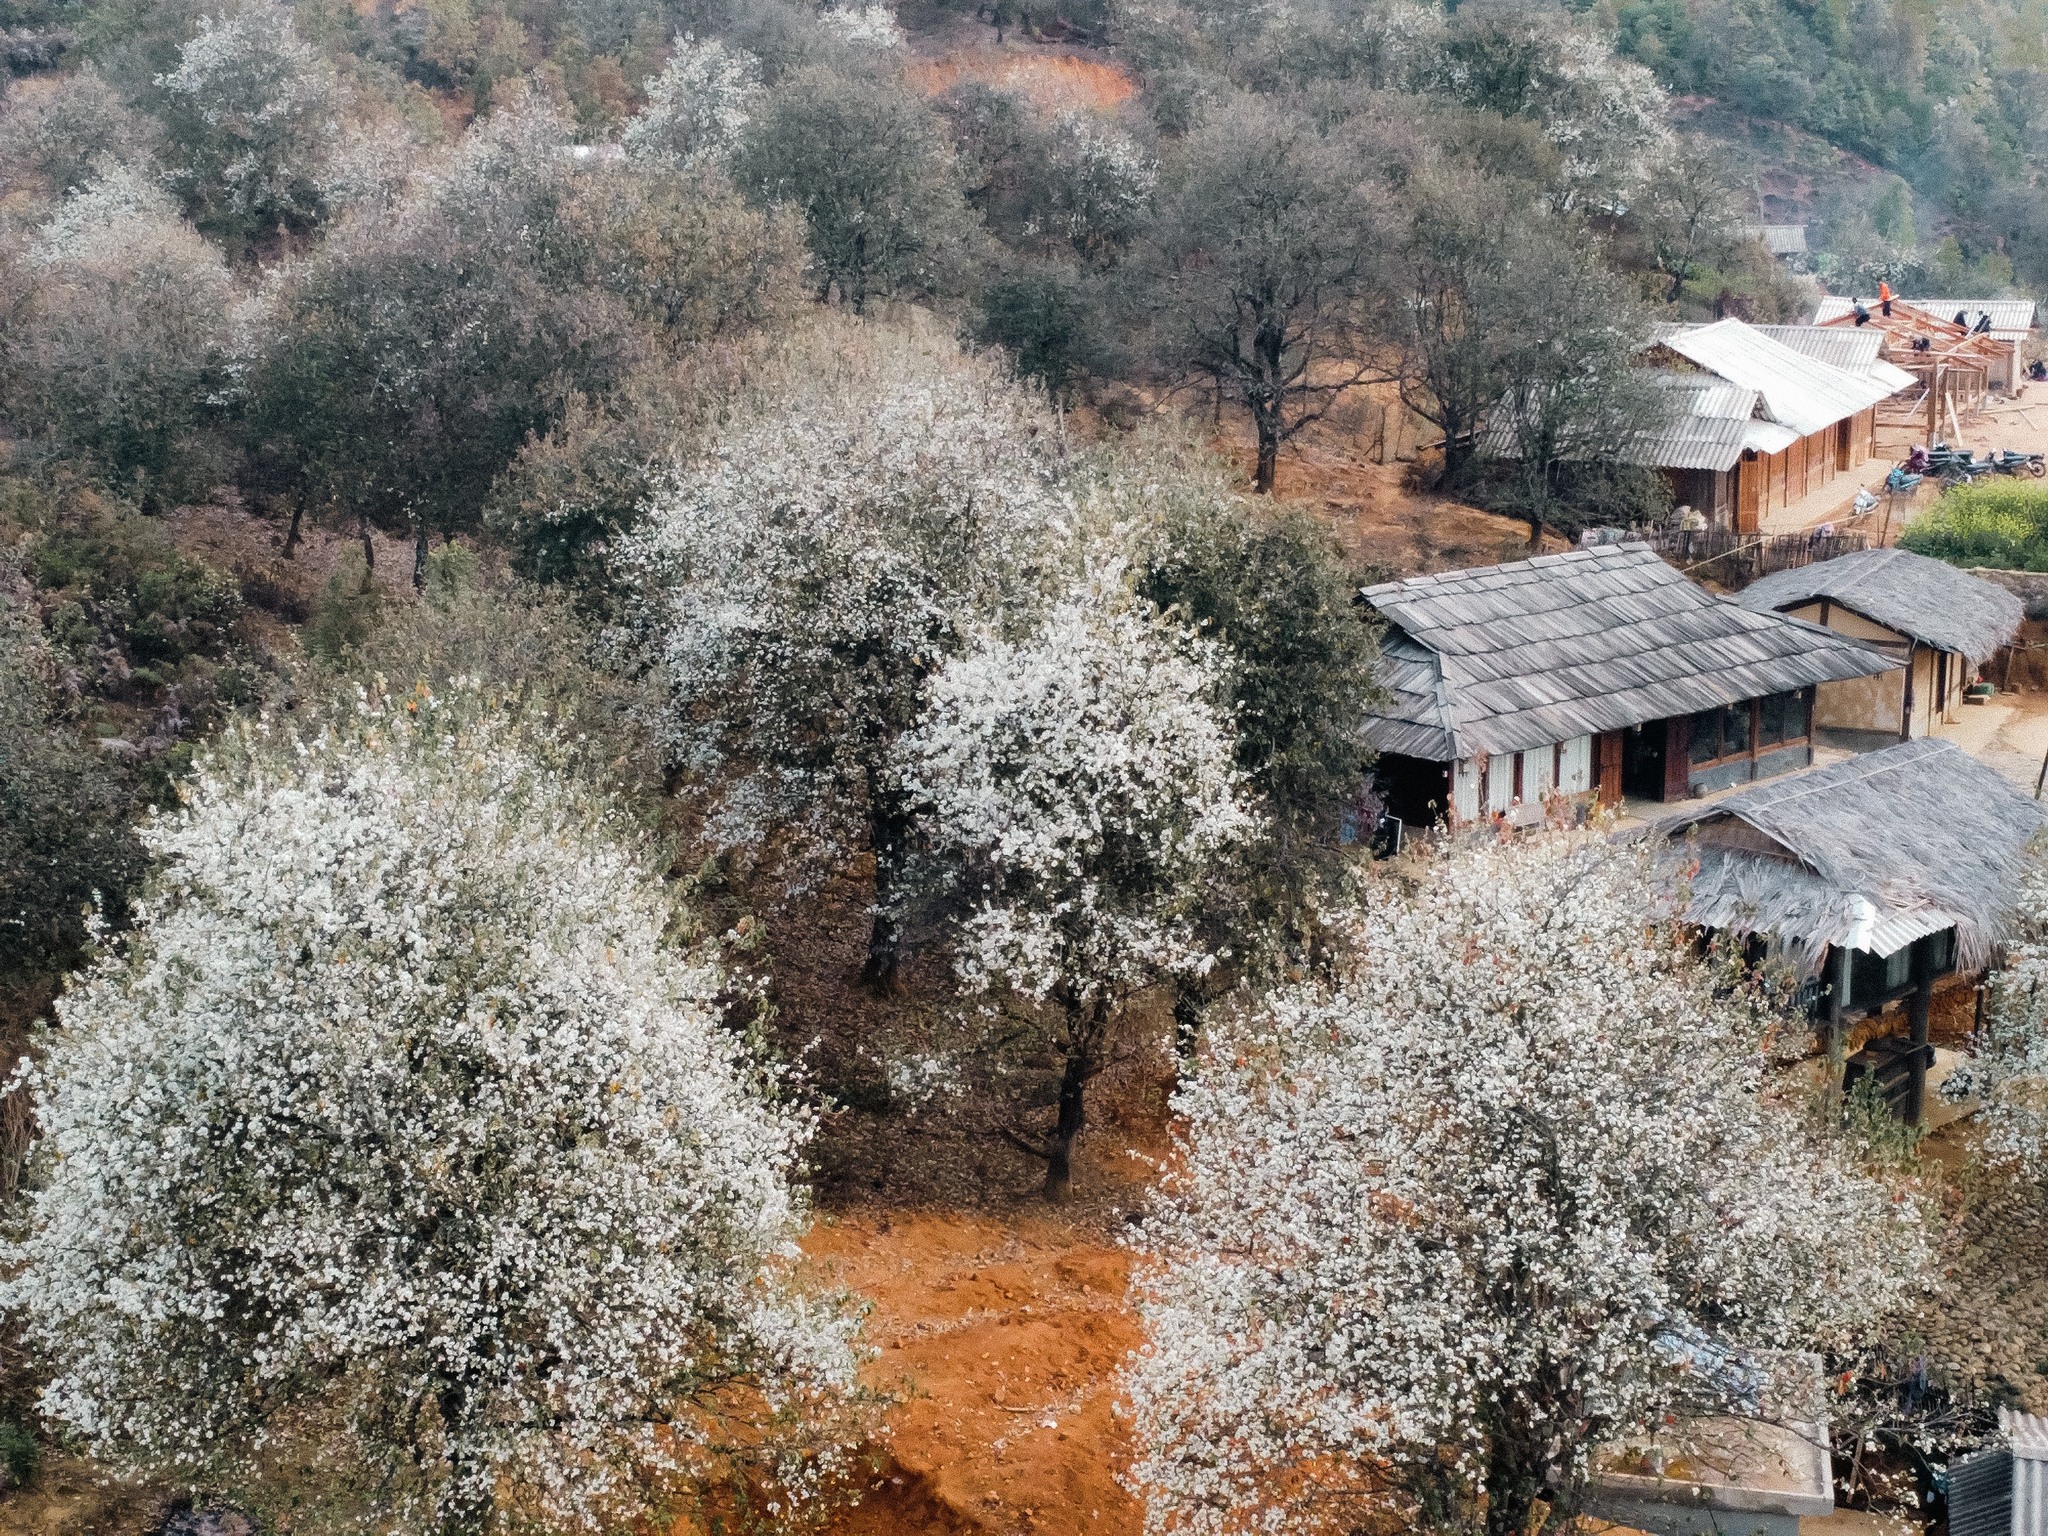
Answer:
[1636,319,1911,532]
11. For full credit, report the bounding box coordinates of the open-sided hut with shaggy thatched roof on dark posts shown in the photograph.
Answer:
[1653,739,2044,1120]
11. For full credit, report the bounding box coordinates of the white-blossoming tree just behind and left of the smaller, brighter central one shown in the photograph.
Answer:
[629,324,1071,985]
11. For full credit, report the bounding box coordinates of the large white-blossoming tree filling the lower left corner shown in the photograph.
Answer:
[0,686,854,1532]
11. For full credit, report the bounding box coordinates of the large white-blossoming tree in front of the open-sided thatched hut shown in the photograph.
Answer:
[1130,836,1927,1536]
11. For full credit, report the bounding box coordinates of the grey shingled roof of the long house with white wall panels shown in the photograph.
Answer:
[1364,545,1898,762]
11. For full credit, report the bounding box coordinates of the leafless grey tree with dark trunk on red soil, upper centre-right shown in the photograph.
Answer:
[1141,96,1393,492]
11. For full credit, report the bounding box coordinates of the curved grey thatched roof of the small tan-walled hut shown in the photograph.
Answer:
[1739,549,2025,666]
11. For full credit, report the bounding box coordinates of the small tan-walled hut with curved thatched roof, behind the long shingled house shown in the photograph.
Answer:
[1737,549,2025,745]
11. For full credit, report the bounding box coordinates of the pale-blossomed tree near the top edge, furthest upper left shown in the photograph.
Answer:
[156,0,342,242]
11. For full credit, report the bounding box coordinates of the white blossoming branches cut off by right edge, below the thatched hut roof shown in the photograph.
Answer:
[1942,858,2048,1178]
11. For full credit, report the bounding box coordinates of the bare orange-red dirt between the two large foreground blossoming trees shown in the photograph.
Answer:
[805,1210,1145,1536]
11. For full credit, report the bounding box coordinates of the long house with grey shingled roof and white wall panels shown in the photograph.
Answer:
[1360,545,1898,825]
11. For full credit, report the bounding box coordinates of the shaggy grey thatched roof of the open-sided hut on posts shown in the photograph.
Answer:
[1655,737,2044,975]
